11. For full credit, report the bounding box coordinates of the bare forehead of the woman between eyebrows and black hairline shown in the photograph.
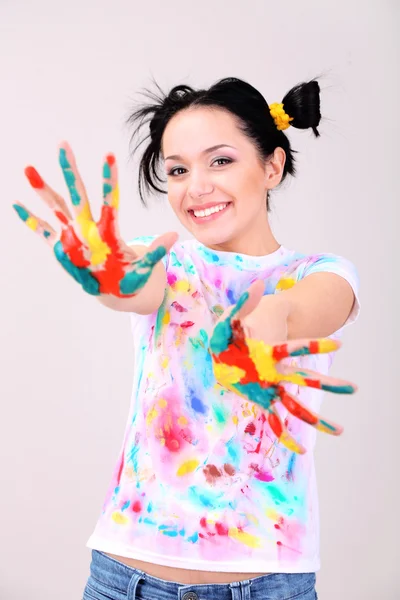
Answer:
[161,107,249,157]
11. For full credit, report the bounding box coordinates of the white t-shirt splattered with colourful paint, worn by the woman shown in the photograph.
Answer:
[87,237,359,573]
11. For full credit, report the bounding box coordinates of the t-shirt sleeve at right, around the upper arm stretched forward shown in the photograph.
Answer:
[299,254,360,329]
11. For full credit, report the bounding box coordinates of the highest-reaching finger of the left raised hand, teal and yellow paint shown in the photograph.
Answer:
[59,142,93,224]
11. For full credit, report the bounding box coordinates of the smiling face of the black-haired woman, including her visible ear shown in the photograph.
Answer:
[162,107,284,254]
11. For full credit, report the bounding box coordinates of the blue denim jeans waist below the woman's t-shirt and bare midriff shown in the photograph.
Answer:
[83,550,317,600]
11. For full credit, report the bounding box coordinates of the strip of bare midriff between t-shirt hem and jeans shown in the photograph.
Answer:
[104,552,268,585]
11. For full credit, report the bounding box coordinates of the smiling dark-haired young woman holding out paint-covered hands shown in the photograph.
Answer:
[15,78,358,600]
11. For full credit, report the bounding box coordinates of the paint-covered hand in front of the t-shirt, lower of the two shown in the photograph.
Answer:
[210,282,356,454]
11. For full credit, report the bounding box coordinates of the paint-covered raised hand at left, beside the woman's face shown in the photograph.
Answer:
[14,142,178,298]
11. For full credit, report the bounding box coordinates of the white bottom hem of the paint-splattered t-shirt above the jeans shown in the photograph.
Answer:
[86,535,320,573]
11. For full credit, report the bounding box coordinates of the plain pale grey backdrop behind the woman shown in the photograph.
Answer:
[0,0,400,600]
